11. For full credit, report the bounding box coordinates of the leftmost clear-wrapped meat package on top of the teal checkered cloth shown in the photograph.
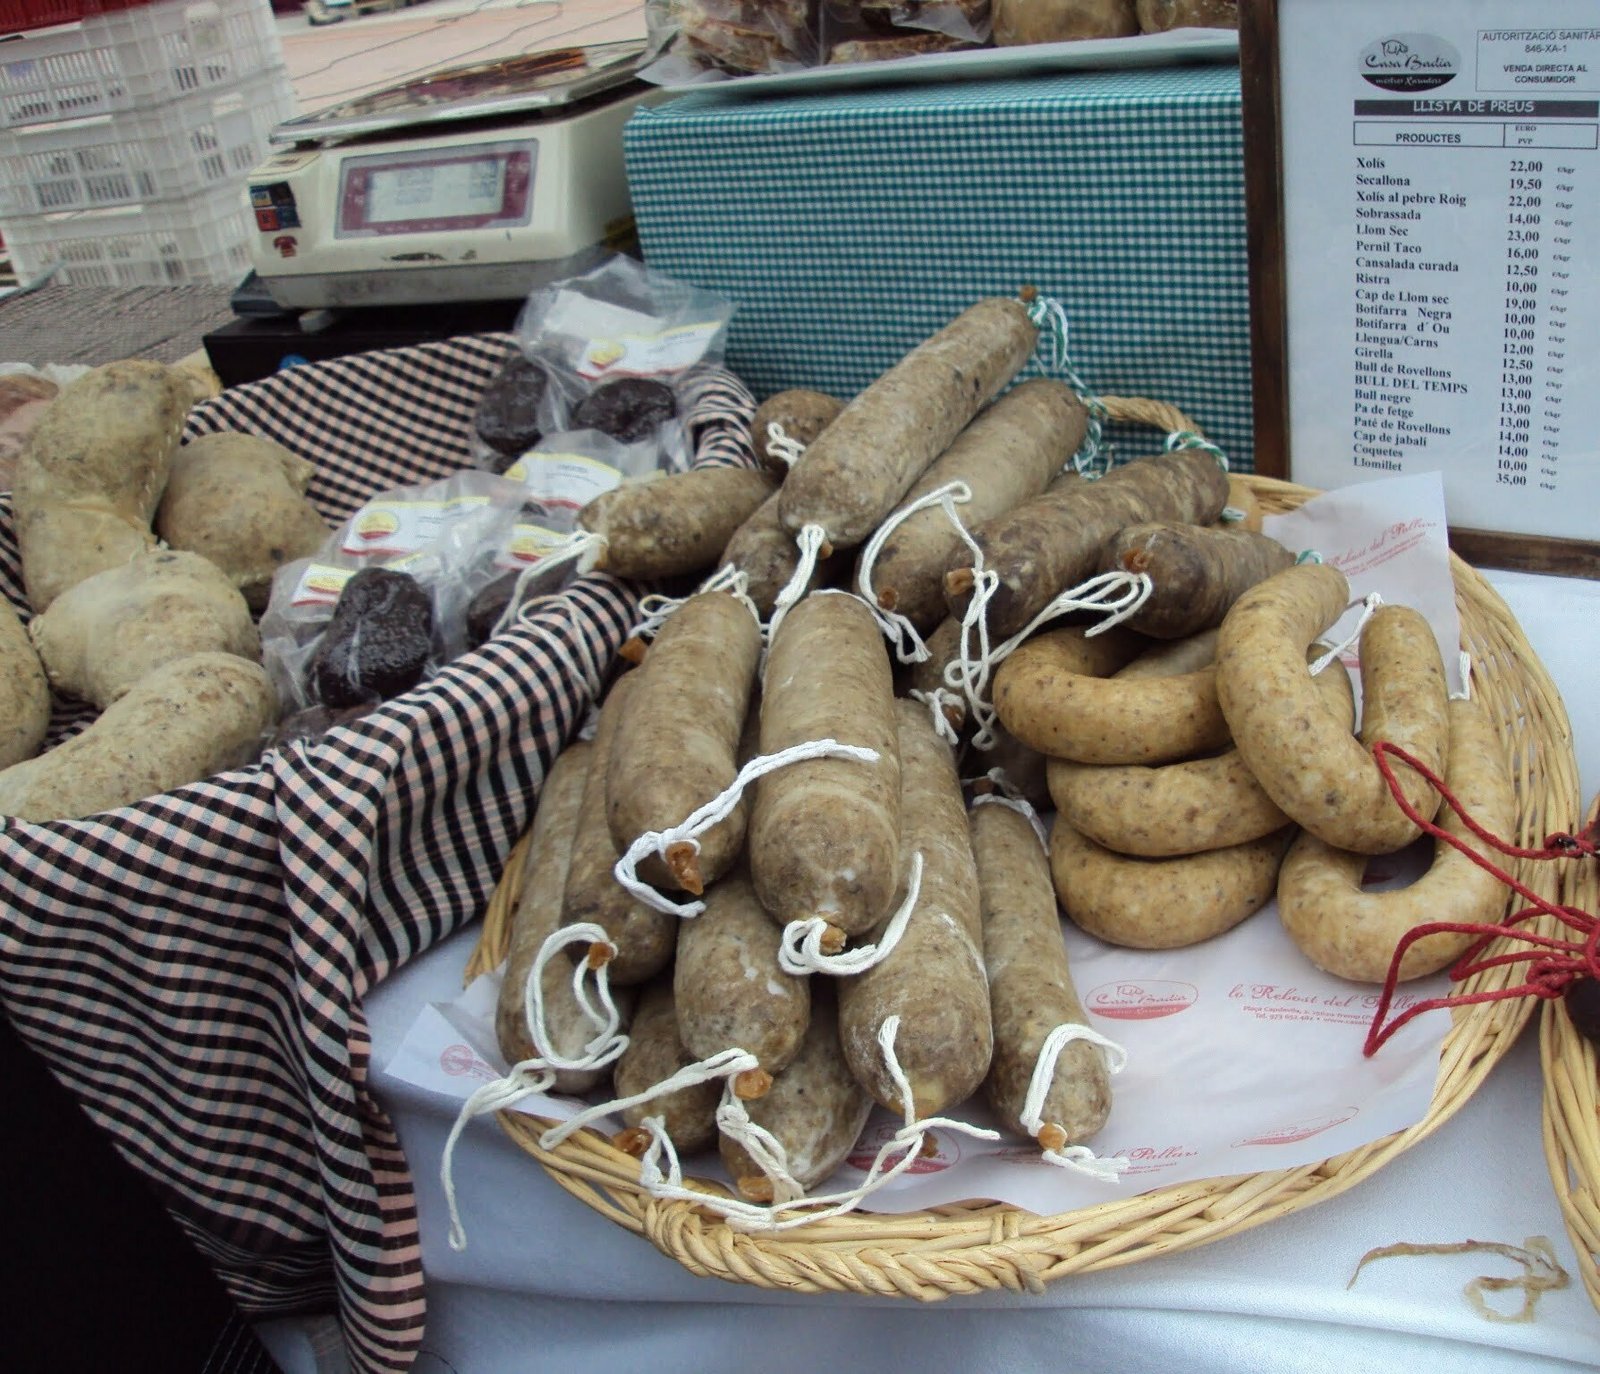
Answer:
[643,0,819,85]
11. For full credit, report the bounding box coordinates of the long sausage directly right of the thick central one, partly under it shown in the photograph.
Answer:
[838,701,994,1120]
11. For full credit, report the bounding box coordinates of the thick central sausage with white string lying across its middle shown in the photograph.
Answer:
[747,592,901,936]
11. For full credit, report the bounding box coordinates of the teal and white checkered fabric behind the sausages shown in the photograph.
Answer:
[626,66,1253,472]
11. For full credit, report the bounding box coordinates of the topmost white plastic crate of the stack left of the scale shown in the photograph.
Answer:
[0,0,283,128]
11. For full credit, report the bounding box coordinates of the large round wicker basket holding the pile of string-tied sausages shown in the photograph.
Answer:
[467,467,1574,1300]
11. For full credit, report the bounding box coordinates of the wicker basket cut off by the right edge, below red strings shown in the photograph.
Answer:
[1539,800,1600,1308]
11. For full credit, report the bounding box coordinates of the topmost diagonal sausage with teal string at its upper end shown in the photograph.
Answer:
[778,298,1038,549]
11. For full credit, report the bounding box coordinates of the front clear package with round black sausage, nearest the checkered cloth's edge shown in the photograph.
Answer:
[261,470,526,737]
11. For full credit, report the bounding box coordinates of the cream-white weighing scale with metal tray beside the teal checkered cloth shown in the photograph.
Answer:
[250,40,659,310]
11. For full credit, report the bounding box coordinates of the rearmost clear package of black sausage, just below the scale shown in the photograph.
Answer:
[517,254,733,470]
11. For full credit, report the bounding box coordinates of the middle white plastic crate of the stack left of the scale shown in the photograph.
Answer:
[0,69,294,222]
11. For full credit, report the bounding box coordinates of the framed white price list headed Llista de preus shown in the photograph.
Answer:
[1240,0,1600,576]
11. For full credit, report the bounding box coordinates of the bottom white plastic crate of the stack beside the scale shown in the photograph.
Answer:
[0,182,256,286]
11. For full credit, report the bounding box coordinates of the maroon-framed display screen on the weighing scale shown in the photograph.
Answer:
[336,142,538,238]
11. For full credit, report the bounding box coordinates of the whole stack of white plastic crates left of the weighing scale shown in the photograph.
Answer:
[0,0,294,286]
